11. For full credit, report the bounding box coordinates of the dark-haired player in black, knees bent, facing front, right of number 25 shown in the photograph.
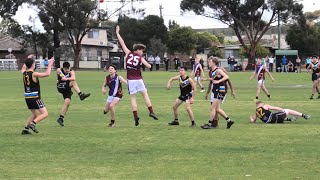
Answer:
[167,67,196,127]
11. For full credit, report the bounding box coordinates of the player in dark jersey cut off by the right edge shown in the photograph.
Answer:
[307,56,320,99]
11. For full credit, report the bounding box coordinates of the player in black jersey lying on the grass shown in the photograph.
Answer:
[250,101,310,123]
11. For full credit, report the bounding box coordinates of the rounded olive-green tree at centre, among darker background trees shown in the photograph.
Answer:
[167,27,197,55]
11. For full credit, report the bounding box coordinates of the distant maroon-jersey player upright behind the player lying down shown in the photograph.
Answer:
[250,58,274,100]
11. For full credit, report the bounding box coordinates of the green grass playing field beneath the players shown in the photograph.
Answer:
[0,71,320,179]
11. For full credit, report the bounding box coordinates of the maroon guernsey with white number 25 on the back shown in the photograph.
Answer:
[126,52,142,80]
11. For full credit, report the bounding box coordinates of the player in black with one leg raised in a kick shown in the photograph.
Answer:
[57,62,90,126]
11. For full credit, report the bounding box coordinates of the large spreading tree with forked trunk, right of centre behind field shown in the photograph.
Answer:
[180,0,303,62]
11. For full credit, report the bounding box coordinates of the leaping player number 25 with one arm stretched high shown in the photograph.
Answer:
[116,26,158,126]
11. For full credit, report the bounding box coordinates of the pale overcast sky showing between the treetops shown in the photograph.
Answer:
[15,0,320,29]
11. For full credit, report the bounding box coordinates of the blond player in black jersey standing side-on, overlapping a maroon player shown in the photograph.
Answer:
[201,57,234,129]
